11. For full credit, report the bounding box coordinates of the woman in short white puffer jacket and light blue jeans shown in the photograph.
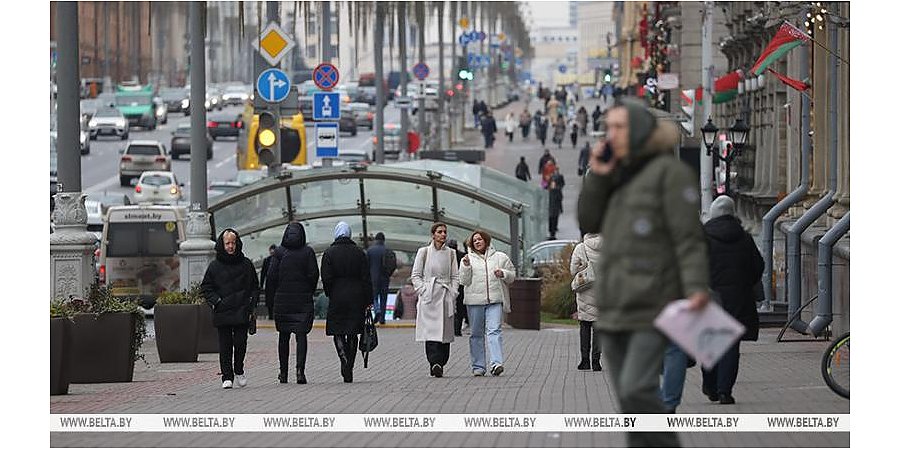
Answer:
[459,230,516,377]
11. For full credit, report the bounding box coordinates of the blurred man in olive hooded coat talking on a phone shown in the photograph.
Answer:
[578,99,709,447]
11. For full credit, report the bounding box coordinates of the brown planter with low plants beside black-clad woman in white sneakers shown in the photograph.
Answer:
[153,284,208,363]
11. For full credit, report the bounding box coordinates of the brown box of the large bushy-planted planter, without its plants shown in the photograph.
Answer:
[69,313,137,383]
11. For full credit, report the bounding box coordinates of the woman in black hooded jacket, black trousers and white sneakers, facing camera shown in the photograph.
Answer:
[200,228,259,389]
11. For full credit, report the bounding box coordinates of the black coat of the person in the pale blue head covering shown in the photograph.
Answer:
[322,237,372,336]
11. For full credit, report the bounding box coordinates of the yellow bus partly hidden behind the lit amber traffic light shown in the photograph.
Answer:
[236,102,307,170]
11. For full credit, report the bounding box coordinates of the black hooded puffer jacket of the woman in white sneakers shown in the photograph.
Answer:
[200,228,259,327]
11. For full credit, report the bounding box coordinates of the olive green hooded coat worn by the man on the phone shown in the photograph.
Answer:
[578,100,709,331]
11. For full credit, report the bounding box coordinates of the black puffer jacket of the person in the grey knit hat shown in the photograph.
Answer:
[703,216,765,341]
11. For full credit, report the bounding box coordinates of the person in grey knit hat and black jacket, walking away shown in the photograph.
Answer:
[703,195,765,405]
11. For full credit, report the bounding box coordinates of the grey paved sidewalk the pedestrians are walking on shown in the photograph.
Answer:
[50,325,850,447]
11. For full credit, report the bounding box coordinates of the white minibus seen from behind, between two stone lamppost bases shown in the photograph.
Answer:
[99,205,186,315]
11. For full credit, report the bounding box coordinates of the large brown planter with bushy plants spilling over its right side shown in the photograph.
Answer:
[65,283,147,383]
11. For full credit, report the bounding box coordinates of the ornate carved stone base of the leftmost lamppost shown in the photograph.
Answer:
[50,192,96,300]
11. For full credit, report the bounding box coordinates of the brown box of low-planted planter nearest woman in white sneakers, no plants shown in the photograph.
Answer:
[153,304,201,363]
